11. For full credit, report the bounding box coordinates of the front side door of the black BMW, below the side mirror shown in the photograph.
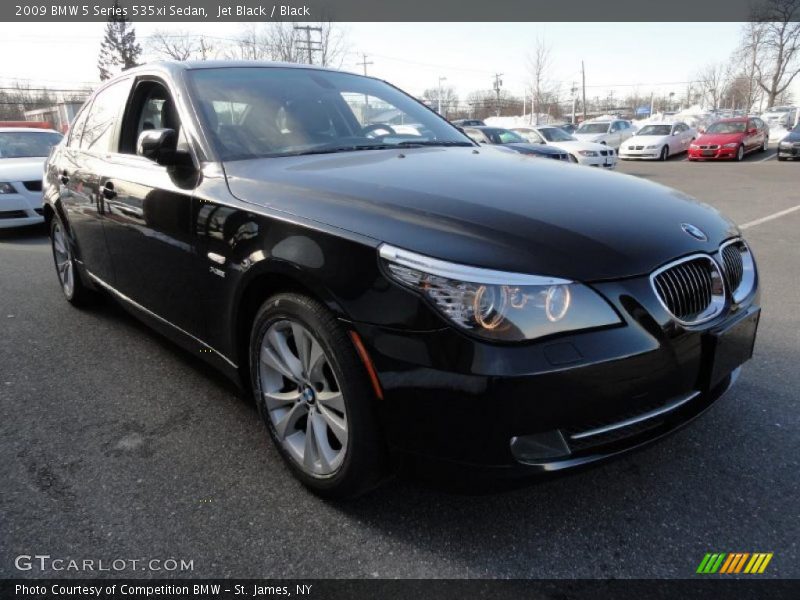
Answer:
[100,77,204,337]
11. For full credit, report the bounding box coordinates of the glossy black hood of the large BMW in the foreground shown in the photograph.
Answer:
[224,148,737,281]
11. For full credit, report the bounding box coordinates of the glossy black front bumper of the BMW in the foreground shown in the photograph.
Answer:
[356,278,759,476]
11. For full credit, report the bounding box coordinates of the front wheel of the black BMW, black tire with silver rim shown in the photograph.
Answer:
[250,293,386,498]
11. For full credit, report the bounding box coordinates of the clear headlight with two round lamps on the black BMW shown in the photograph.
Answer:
[379,244,621,342]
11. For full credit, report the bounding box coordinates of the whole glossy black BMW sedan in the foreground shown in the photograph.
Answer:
[44,62,760,497]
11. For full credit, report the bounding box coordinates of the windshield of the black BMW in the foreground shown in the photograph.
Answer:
[189,67,473,160]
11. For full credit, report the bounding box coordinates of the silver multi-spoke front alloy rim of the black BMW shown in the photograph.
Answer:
[259,319,348,477]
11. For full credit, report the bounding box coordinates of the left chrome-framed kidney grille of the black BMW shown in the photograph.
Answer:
[650,254,725,325]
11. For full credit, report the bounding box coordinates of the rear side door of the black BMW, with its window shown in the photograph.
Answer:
[58,79,131,285]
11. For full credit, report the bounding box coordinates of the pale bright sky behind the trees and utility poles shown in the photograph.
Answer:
[0,23,800,108]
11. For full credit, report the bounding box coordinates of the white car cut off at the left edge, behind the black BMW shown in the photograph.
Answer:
[0,127,63,229]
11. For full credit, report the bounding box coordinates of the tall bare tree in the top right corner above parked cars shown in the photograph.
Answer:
[745,0,800,106]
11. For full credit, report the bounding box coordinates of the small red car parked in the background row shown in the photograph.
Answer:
[689,117,769,160]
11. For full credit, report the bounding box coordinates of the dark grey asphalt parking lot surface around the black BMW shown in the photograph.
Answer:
[0,148,800,578]
